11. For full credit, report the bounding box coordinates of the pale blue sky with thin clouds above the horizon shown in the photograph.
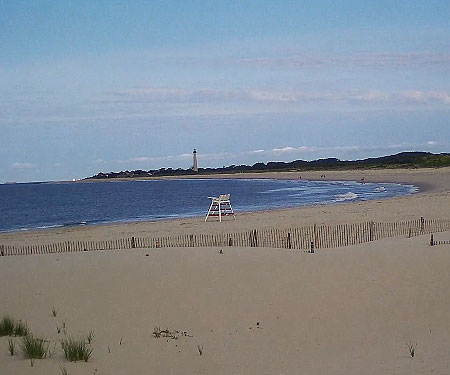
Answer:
[0,0,450,183]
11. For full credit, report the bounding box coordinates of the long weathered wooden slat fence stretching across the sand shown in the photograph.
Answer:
[0,218,450,256]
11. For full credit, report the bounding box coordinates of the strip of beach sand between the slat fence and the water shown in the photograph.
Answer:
[0,167,450,244]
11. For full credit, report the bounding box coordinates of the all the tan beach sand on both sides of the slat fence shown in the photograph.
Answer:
[0,169,450,375]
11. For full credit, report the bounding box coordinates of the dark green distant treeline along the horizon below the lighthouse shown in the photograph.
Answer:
[87,152,450,179]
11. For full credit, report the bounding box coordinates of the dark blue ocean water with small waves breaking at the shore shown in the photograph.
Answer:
[0,179,418,232]
